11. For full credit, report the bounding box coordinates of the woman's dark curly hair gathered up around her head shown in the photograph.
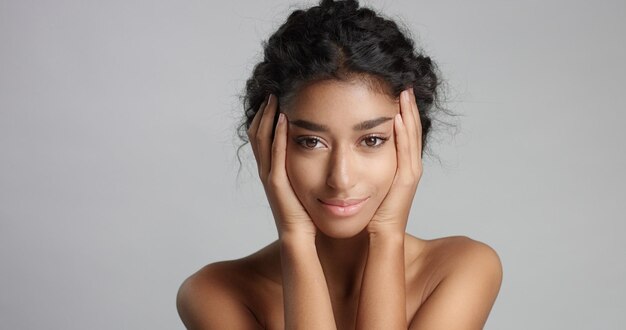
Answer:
[238,0,448,159]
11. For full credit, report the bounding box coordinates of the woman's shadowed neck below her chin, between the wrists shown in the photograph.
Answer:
[315,230,369,298]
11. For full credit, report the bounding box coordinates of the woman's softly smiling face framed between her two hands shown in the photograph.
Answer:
[285,80,399,238]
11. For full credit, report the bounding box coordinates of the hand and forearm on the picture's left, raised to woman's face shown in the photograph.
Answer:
[248,95,336,329]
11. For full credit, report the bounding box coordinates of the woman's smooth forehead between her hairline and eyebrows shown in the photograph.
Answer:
[286,80,399,125]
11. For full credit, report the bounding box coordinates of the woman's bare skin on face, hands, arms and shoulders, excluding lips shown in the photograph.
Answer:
[177,80,502,329]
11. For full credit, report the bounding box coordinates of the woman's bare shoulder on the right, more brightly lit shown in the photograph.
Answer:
[411,236,502,329]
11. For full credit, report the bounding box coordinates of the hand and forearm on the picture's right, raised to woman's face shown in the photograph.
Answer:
[357,90,422,330]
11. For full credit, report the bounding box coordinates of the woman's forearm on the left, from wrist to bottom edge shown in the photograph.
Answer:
[280,235,337,330]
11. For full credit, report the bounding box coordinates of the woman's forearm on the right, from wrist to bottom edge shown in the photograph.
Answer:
[356,234,407,330]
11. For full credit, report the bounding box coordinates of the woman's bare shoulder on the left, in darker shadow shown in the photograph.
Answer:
[176,245,275,329]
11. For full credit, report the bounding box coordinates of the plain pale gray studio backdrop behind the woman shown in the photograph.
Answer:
[0,0,626,329]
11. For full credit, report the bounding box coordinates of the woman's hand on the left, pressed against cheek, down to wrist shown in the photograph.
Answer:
[247,94,317,238]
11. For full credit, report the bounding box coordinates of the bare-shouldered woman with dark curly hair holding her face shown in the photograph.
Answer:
[177,0,502,329]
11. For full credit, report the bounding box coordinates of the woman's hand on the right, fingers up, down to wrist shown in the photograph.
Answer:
[367,88,422,237]
